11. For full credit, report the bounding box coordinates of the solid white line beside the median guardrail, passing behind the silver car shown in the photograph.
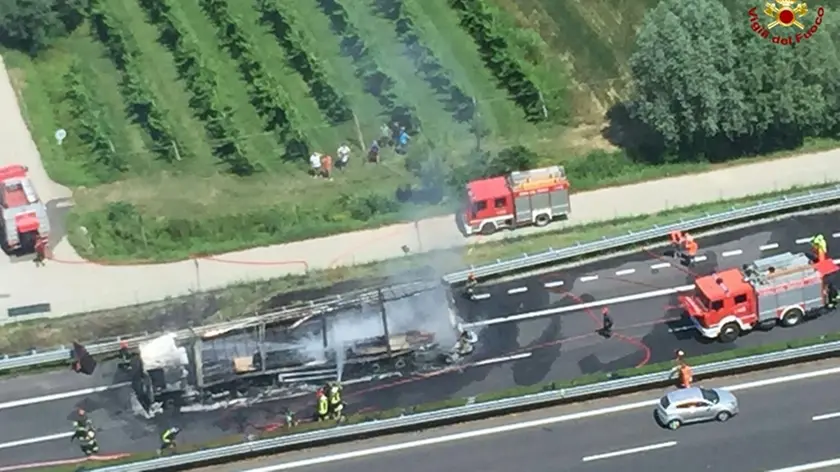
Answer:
[244,367,840,472]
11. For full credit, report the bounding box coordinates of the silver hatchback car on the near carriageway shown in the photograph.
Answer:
[655,387,738,430]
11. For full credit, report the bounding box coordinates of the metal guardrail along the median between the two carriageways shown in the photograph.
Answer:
[87,341,840,472]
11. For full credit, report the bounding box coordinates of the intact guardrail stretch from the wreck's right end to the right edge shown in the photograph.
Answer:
[443,185,840,285]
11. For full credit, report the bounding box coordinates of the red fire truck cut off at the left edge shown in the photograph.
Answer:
[0,165,50,252]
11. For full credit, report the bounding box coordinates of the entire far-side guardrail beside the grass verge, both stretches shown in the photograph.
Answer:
[0,185,840,372]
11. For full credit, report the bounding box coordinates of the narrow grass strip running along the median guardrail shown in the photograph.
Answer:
[37,332,840,472]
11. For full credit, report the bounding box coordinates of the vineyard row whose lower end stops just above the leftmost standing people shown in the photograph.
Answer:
[199,0,309,160]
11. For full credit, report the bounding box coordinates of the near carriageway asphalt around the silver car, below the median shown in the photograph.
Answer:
[204,368,840,472]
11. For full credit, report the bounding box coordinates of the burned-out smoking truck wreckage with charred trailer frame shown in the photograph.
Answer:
[127,284,478,414]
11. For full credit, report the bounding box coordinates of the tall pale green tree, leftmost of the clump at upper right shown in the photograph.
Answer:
[629,0,746,160]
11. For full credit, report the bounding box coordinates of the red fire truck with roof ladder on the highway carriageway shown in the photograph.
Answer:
[679,252,840,342]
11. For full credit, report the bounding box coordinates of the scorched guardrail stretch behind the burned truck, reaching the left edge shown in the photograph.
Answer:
[0,281,439,372]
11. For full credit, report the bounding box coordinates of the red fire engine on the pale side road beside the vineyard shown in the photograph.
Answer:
[460,166,571,235]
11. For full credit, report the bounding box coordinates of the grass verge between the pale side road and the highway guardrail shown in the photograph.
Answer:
[0,181,840,353]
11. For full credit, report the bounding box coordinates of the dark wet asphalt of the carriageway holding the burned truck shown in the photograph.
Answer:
[0,213,840,465]
